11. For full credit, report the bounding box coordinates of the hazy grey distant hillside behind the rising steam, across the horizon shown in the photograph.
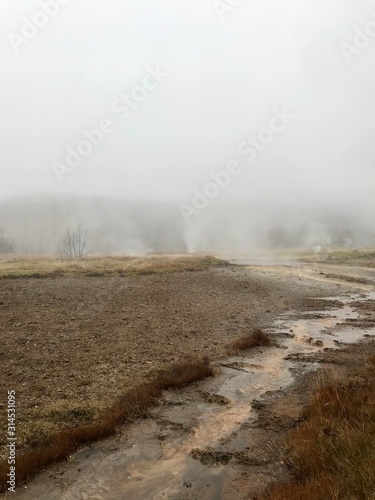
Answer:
[0,196,375,255]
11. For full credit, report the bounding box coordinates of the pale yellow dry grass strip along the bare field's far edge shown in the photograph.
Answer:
[0,254,229,279]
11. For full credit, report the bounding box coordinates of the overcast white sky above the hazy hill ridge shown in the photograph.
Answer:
[0,0,375,201]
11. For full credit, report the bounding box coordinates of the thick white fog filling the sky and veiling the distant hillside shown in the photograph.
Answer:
[0,0,375,255]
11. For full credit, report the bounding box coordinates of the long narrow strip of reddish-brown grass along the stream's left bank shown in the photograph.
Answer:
[0,359,214,492]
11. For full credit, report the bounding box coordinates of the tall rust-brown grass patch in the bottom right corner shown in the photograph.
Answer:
[265,357,375,500]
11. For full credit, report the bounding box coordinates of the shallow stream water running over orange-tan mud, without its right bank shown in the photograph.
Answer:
[12,292,375,500]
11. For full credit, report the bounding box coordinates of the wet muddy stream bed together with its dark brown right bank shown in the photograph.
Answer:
[8,286,375,500]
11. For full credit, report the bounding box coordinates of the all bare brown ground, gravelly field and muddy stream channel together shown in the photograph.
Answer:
[0,264,375,499]
